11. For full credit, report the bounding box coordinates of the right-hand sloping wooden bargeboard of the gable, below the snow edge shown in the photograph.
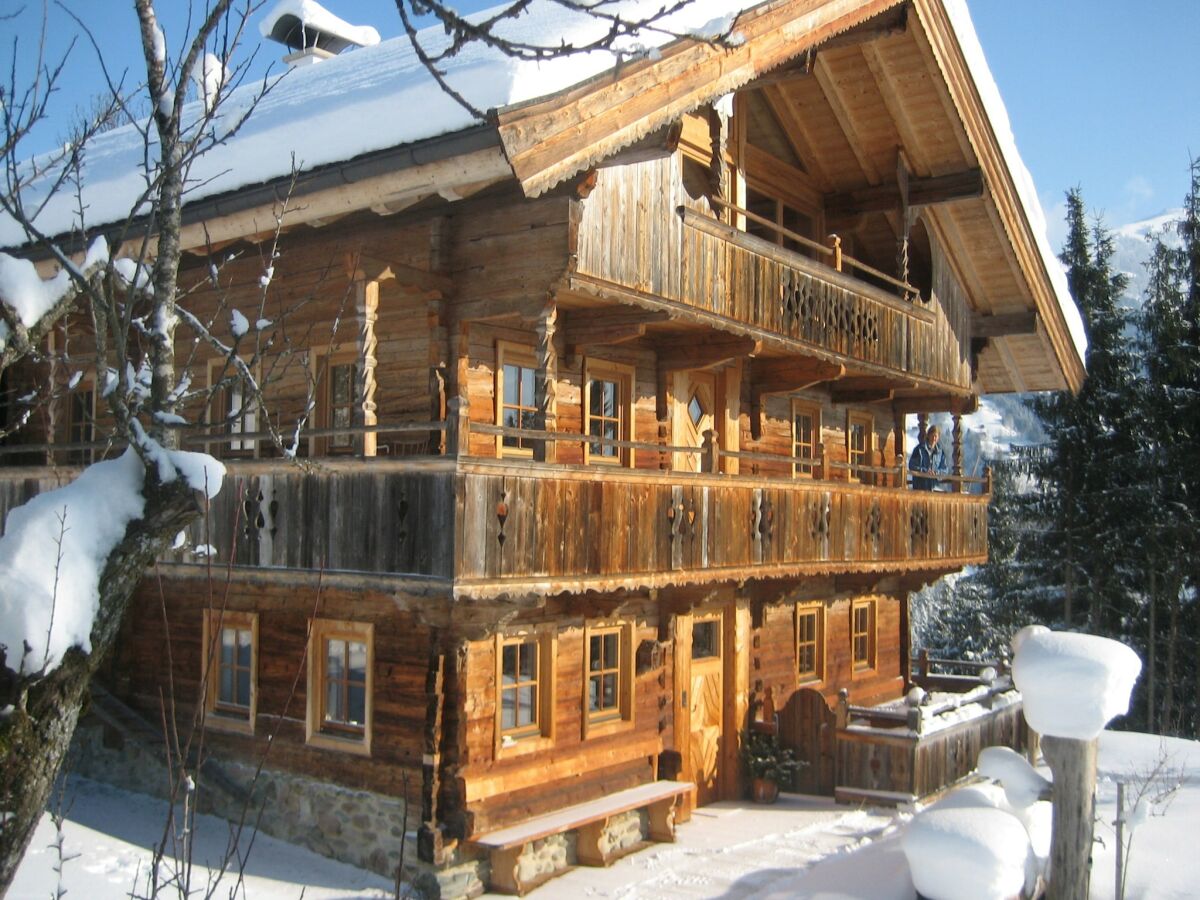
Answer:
[913,0,1085,392]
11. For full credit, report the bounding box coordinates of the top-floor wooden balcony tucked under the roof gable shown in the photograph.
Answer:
[572,159,971,390]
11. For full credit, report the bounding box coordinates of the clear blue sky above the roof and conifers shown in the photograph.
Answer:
[0,0,1200,240]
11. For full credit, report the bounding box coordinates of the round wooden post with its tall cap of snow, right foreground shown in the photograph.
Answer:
[1013,625,1141,900]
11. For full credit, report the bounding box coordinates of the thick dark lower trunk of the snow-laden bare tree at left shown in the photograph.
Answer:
[0,479,202,896]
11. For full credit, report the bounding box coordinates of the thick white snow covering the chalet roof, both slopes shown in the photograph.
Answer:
[0,0,1086,369]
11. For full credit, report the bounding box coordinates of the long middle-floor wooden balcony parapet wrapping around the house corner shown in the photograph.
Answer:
[0,434,989,598]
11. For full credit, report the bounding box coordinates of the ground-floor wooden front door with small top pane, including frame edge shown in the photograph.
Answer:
[676,611,737,805]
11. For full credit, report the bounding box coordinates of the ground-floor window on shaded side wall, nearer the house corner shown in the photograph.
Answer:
[306,619,374,754]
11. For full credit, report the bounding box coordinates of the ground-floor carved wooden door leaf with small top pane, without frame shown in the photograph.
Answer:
[688,613,725,805]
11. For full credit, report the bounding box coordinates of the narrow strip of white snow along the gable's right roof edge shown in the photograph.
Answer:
[942,0,1087,360]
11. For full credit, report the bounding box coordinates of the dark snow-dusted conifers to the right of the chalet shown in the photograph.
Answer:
[914,161,1200,738]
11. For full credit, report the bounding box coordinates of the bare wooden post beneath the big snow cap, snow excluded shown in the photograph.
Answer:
[1042,736,1098,900]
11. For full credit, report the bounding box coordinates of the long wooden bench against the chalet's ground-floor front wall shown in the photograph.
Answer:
[470,781,695,895]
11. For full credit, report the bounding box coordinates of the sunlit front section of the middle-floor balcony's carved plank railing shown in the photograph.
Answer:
[457,460,988,589]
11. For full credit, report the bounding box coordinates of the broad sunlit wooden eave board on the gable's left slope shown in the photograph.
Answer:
[496,0,905,197]
